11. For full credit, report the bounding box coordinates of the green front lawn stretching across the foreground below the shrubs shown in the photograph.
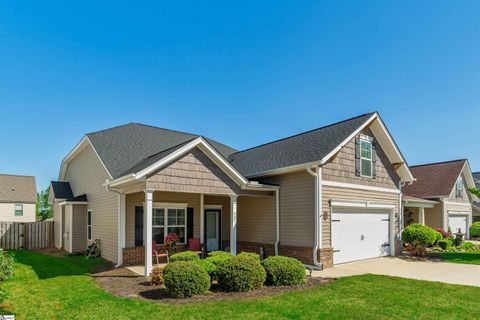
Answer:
[2,251,480,320]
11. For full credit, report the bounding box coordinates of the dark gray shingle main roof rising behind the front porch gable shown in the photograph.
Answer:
[87,123,236,179]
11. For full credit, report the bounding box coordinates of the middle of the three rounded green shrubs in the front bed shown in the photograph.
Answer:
[218,255,266,292]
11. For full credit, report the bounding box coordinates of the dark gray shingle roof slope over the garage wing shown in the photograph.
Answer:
[229,112,374,177]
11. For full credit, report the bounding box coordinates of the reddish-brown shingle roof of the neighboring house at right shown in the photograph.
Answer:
[402,159,467,199]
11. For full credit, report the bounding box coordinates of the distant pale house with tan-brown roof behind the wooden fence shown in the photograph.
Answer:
[0,174,37,222]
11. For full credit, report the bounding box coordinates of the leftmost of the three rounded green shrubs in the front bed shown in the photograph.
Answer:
[163,261,210,298]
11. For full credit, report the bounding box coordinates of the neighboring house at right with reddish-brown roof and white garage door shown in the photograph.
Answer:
[403,160,475,238]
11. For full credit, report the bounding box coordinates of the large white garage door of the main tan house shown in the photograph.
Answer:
[332,208,390,264]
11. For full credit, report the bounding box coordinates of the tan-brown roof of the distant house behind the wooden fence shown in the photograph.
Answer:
[0,174,37,203]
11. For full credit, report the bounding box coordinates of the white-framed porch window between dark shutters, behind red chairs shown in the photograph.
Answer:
[152,208,187,244]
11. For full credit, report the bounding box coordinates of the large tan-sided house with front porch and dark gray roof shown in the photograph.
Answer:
[49,112,414,274]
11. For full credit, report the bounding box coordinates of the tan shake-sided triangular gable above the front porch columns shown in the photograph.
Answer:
[147,149,241,195]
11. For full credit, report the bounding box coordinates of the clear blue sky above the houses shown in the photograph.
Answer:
[0,0,480,188]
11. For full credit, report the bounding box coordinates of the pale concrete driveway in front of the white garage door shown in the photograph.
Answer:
[312,257,480,287]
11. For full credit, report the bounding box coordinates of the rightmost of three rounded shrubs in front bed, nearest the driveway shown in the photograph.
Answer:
[262,256,305,286]
